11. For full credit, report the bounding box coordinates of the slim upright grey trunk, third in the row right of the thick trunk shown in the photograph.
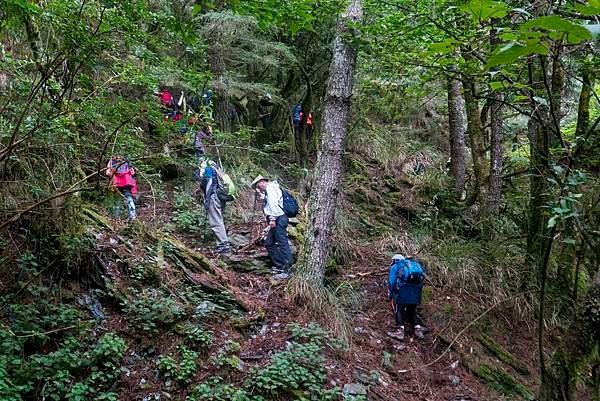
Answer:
[487,91,504,216]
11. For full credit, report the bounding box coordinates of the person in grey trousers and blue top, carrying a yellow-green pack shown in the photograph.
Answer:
[202,166,231,253]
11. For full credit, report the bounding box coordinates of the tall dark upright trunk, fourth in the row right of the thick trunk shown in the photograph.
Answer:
[527,57,550,274]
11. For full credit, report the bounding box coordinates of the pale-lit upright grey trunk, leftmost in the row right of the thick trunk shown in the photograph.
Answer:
[448,67,466,201]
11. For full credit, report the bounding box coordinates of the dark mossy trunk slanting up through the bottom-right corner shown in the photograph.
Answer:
[538,272,600,401]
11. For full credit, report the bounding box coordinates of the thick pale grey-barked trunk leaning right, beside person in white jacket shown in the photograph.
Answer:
[301,0,362,288]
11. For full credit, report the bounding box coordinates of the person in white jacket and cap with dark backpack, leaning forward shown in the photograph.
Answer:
[250,175,298,279]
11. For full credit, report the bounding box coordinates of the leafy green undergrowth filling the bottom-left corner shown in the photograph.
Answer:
[0,301,127,401]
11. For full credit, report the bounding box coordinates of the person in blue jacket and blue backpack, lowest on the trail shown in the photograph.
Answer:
[387,254,425,341]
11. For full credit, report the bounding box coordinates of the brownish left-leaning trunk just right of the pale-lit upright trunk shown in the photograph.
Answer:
[463,75,485,206]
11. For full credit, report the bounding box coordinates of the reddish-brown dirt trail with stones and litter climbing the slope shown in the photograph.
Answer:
[122,183,500,401]
